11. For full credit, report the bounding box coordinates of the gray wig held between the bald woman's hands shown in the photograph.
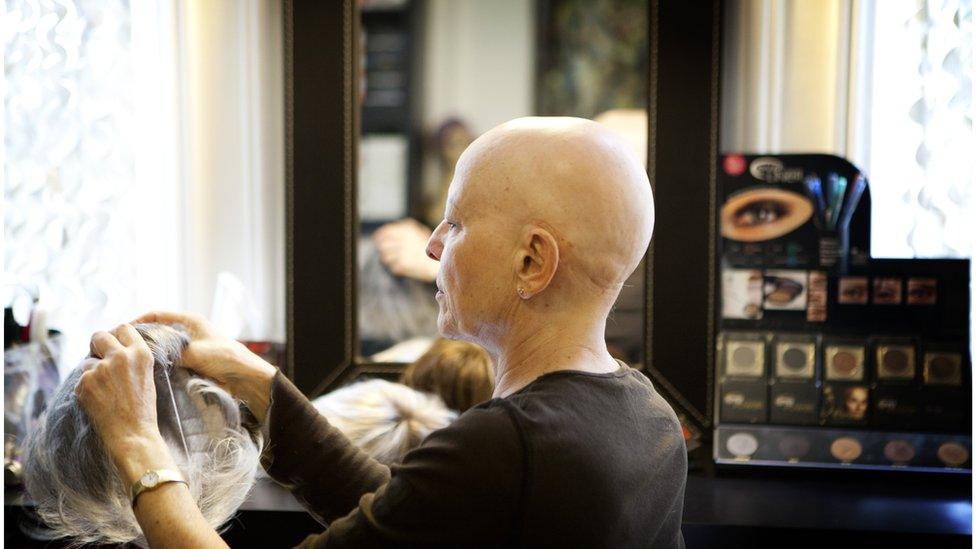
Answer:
[24,324,261,545]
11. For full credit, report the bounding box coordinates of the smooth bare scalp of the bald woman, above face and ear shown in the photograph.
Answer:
[448,117,654,297]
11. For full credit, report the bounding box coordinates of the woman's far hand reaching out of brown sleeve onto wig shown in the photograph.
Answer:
[134,311,278,421]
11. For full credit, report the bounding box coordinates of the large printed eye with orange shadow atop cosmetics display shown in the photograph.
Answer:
[721,187,813,242]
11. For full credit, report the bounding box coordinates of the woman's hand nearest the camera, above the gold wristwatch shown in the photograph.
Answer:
[75,324,172,484]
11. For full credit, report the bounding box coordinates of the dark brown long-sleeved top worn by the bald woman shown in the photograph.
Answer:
[262,365,687,547]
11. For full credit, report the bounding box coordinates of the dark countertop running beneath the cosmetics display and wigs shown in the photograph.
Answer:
[5,473,972,548]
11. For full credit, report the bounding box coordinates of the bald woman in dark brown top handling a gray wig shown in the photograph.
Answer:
[78,118,687,547]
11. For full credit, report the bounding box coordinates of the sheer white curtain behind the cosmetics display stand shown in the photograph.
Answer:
[721,0,976,352]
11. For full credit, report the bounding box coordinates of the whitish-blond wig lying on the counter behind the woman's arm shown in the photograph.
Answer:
[312,379,457,465]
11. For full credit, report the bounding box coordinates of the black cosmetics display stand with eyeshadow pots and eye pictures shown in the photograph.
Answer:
[713,154,972,474]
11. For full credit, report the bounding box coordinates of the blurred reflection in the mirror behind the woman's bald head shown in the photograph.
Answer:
[357,0,648,364]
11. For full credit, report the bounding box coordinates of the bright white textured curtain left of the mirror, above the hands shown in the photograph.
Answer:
[3,0,284,366]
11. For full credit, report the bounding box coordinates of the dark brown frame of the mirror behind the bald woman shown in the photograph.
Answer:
[284,0,724,428]
